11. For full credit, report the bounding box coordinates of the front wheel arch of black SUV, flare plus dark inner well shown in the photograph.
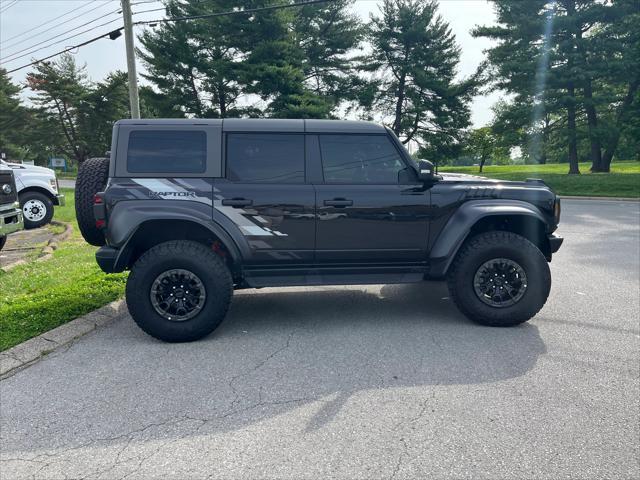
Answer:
[429,200,551,278]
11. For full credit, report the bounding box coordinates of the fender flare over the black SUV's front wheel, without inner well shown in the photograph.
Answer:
[429,199,547,278]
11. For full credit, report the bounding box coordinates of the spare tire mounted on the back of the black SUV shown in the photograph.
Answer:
[75,158,109,247]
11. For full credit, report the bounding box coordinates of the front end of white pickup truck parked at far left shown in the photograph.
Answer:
[2,161,65,228]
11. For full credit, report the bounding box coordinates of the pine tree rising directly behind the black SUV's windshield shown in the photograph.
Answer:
[363,0,477,159]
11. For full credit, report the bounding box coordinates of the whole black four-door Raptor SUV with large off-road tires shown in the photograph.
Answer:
[76,119,562,342]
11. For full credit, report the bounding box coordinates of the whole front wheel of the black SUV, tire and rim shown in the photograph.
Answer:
[447,231,551,327]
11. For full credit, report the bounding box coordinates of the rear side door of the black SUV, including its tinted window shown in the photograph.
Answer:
[214,132,315,266]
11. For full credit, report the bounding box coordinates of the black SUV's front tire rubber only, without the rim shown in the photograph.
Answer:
[447,231,551,327]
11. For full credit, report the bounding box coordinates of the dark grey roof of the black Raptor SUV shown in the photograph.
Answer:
[116,118,385,133]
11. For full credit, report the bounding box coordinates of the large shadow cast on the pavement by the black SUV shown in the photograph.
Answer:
[2,282,546,460]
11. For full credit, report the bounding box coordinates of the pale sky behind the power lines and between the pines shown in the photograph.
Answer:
[0,0,500,127]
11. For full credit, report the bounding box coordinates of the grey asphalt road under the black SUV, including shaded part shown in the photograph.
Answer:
[0,201,640,479]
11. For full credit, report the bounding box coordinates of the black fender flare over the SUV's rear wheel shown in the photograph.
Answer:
[107,200,250,272]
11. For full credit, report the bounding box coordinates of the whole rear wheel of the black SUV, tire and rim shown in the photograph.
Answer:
[126,240,233,342]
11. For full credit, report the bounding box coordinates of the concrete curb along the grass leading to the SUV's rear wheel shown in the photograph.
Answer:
[0,300,126,380]
